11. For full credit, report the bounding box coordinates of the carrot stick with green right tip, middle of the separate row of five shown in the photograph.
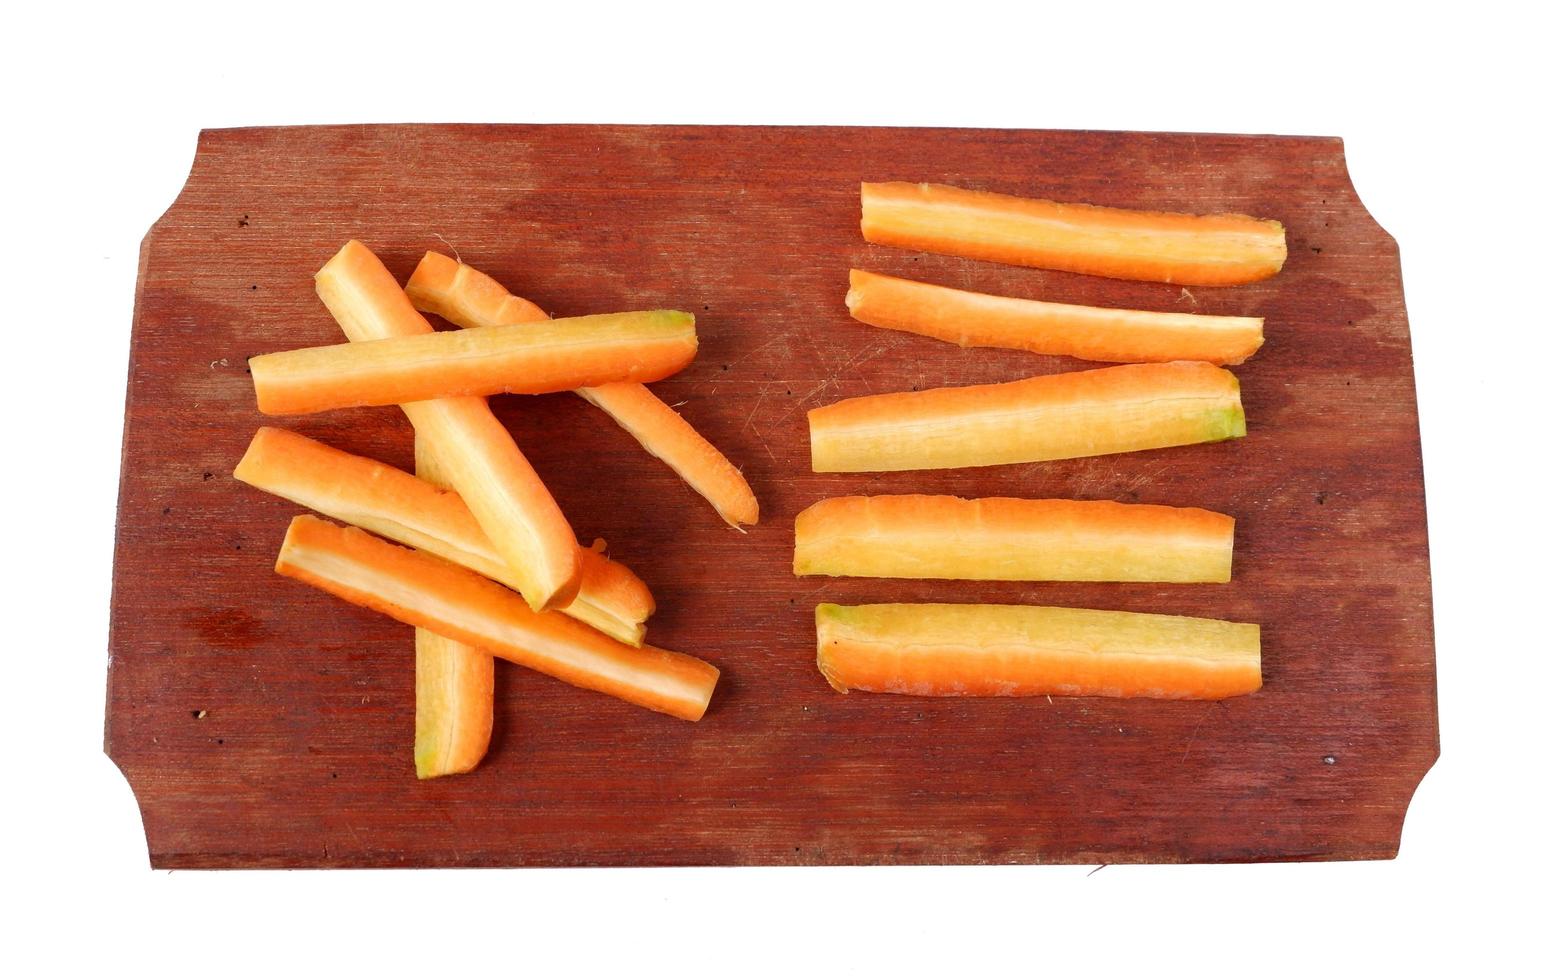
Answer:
[809,361,1244,472]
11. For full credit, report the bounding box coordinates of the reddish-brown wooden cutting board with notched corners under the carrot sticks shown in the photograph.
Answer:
[107,127,1437,867]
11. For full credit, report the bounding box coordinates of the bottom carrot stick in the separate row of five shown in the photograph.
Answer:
[815,602,1260,699]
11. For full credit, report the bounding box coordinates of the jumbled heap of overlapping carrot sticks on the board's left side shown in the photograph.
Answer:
[235,241,760,778]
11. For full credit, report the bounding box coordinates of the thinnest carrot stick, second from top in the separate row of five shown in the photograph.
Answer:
[848,269,1265,364]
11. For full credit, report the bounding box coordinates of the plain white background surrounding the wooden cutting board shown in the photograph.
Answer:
[0,0,1544,977]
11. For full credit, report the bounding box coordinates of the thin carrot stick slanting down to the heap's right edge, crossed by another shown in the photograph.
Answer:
[408,252,760,528]
